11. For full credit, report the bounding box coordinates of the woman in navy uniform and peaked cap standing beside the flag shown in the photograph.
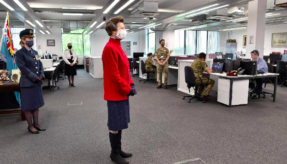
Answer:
[16,29,46,134]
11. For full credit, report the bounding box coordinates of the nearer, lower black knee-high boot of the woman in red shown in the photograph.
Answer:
[109,132,128,164]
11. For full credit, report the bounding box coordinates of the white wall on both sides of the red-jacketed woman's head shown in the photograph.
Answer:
[91,29,146,56]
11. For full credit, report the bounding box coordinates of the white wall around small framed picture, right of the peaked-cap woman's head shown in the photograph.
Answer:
[34,27,63,56]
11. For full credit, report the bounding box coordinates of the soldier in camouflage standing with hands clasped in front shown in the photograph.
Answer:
[155,39,170,89]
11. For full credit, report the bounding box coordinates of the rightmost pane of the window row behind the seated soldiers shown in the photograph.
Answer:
[207,31,220,54]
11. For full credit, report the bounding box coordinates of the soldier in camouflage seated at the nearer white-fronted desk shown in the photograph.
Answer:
[191,52,215,101]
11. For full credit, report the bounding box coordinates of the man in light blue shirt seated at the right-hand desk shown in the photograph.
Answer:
[251,50,268,99]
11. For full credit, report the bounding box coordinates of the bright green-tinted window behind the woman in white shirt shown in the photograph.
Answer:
[62,29,84,55]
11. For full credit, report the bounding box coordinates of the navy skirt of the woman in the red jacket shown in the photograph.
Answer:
[108,99,130,131]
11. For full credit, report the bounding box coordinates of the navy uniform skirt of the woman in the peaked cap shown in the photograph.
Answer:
[21,85,44,111]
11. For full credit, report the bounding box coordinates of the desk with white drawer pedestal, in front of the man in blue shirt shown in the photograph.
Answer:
[211,73,279,107]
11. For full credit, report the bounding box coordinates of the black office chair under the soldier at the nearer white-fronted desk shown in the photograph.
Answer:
[182,66,209,103]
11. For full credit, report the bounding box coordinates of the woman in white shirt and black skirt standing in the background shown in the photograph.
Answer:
[63,43,77,87]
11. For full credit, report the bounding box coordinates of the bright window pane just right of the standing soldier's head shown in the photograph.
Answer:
[174,30,185,55]
